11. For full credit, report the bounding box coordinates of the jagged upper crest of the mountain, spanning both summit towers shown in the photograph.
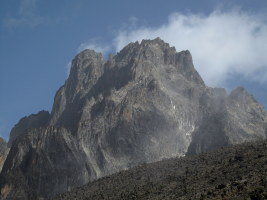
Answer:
[50,38,205,129]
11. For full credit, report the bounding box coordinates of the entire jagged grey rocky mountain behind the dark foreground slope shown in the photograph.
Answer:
[0,38,267,199]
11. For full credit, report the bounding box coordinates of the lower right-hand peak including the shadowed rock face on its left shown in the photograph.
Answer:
[187,87,267,154]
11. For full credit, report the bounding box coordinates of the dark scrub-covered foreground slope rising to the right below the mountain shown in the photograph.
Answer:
[54,140,267,200]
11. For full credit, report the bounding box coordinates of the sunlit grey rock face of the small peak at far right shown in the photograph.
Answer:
[226,87,267,144]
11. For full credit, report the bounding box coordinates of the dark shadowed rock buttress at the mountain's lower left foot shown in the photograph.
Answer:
[0,127,89,199]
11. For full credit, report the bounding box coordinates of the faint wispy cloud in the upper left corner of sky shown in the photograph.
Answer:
[4,0,45,28]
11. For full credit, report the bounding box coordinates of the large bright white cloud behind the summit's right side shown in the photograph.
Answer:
[111,10,267,86]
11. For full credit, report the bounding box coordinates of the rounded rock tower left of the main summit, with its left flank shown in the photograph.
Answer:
[50,49,105,125]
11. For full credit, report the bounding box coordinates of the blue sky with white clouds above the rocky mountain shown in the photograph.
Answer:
[0,0,267,139]
